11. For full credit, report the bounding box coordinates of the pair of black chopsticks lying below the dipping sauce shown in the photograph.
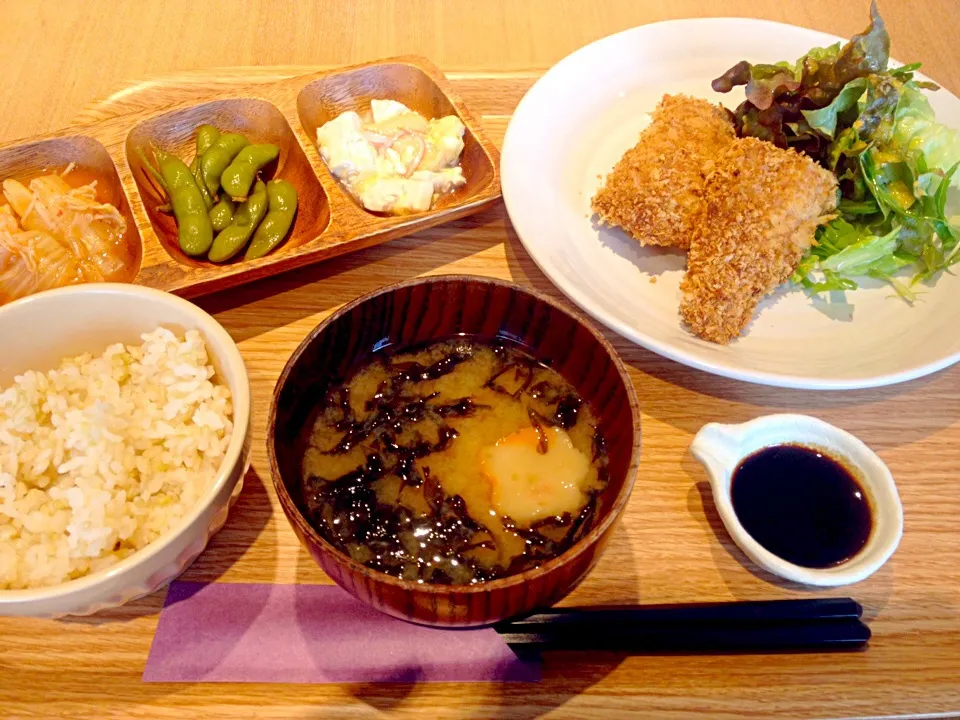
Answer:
[496,598,870,653]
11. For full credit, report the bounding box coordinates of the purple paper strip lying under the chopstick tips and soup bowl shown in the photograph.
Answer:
[143,582,540,683]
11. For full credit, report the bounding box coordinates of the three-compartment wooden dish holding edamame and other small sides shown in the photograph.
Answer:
[0,56,500,297]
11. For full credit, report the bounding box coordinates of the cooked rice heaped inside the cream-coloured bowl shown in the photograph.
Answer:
[0,327,233,590]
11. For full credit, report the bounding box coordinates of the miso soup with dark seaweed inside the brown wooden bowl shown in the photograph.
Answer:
[300,338,608,585]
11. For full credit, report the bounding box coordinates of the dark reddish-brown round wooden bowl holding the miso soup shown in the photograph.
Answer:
[267,275,640,626]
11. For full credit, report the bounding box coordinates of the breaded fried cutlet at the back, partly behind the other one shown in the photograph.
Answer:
[592,95,736,249]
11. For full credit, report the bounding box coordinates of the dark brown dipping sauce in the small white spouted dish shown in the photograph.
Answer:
[730,445,873,568]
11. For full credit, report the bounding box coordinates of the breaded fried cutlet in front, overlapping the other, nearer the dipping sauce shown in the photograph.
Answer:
[680,138,837,345]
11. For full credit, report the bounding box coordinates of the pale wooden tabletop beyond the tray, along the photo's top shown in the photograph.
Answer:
[0,0,960,141]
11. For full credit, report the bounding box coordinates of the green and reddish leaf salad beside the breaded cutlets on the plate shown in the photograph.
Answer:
[713,2,960,302]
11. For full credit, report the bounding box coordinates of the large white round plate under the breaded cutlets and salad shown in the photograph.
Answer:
[501,17,960,389]
